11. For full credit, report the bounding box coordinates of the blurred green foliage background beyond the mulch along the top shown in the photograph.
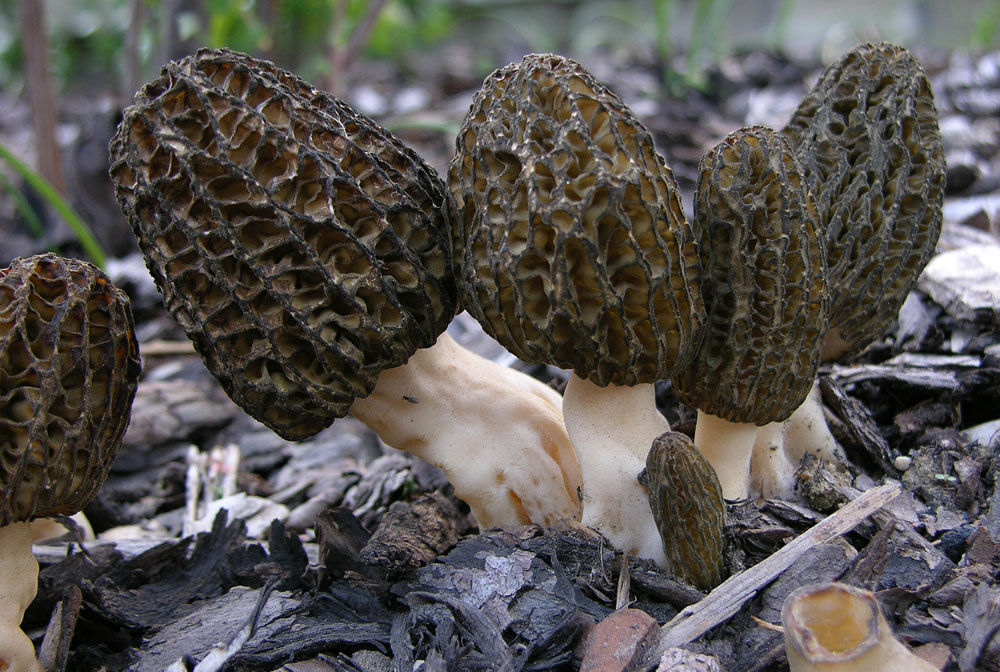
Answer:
[0,0,1000,100]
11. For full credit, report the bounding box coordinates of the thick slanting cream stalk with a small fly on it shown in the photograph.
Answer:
[351,334,580,530]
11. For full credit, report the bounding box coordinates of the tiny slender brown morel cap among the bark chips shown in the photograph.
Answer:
[641,432,726,590]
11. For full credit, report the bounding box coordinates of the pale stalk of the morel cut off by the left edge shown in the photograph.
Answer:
[0,523,43,672]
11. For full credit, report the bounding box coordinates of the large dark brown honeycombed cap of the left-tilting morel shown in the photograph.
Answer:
[111,50,457,439]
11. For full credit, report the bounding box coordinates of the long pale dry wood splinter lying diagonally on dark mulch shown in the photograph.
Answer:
[642,483,902,669]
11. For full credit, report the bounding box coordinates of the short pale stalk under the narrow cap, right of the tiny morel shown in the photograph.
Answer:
[694,411,759,500]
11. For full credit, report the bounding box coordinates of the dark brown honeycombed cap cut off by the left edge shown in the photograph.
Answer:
[0,254,141,526]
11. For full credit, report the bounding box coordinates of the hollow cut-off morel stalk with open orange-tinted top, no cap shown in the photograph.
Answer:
[781,583,939,672]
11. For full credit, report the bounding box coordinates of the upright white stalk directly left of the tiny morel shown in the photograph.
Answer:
[563,374,670,567]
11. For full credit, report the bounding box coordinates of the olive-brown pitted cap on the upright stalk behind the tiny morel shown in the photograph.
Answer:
[449,54,703,385]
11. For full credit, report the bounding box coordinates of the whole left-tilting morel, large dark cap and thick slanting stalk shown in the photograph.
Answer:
[111,50,579,528]
